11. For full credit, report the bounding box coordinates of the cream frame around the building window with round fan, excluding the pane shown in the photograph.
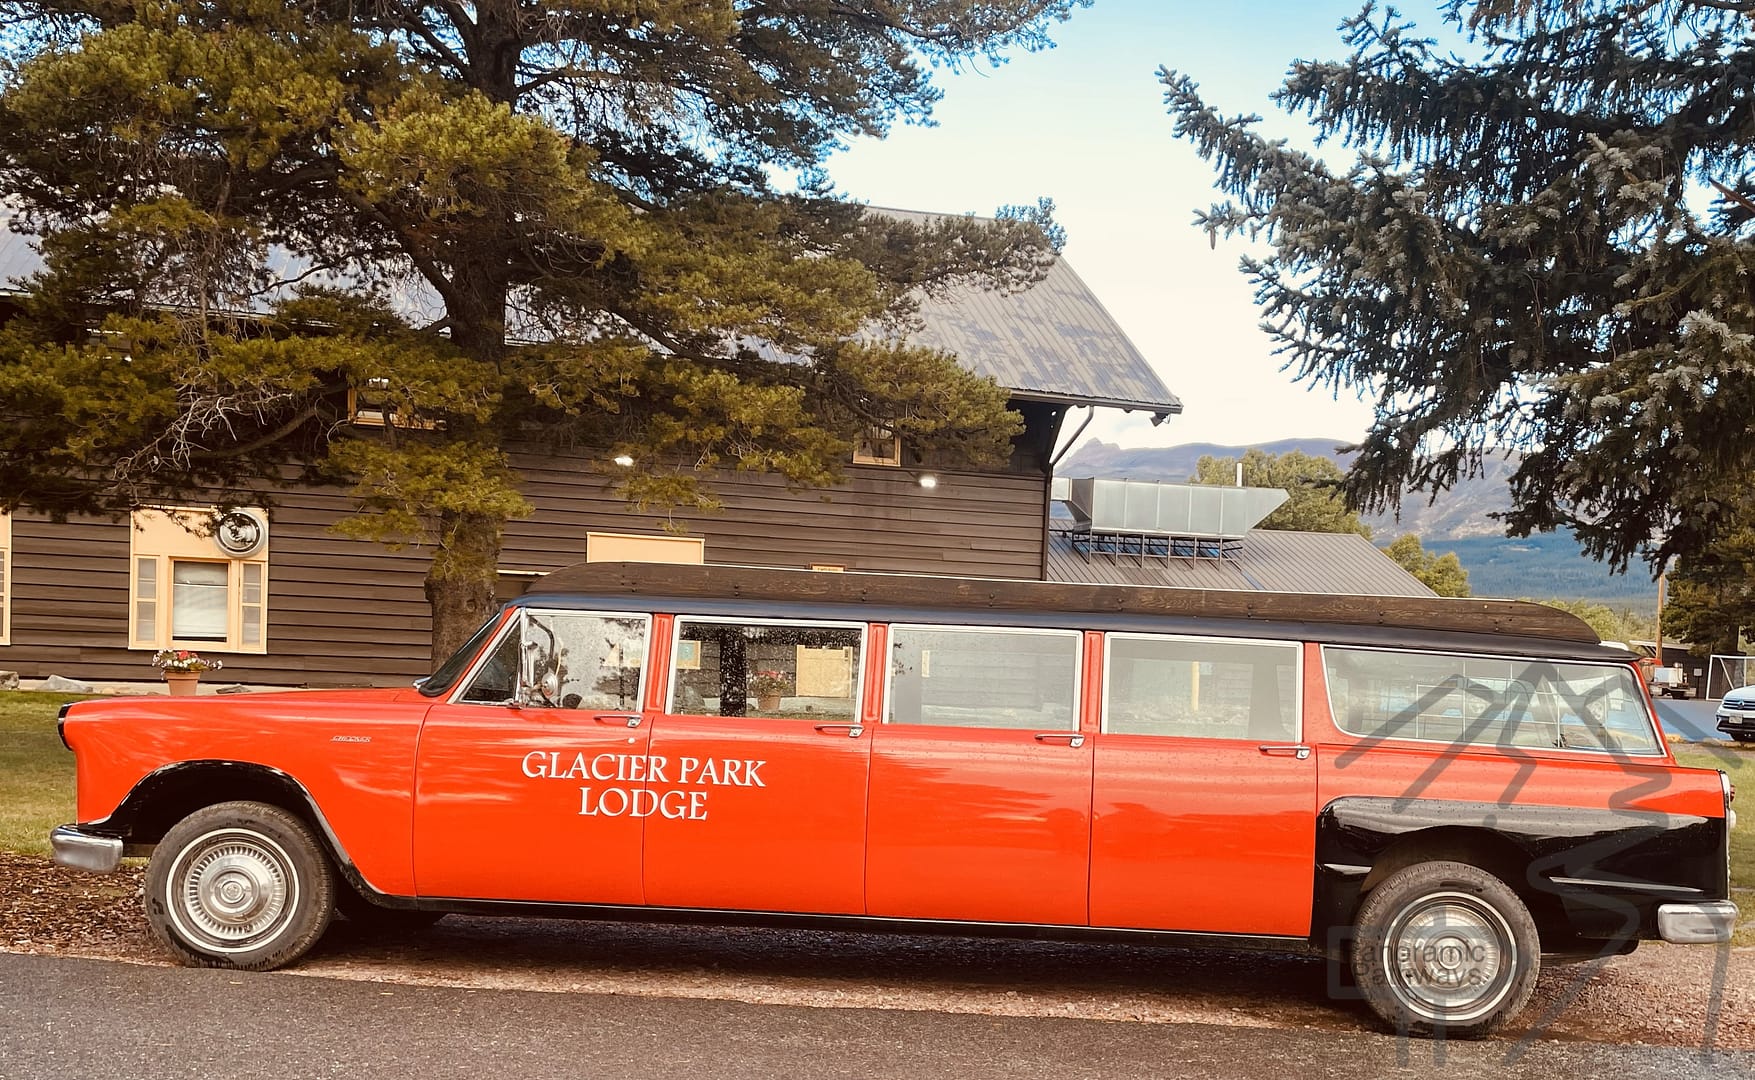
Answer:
[128,506,270,655]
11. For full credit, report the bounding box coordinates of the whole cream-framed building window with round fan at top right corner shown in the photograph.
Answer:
[128,508,269,653]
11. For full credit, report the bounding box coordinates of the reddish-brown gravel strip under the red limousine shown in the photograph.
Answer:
[0,853,1755,1050]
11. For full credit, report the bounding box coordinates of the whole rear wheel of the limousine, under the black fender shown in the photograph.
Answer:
[1353,862,1541,1038]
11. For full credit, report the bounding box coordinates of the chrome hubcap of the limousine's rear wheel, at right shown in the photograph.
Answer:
[1383,892,1518,1022]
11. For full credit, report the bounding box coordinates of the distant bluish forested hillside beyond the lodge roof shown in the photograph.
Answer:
[1057,439,1657,609]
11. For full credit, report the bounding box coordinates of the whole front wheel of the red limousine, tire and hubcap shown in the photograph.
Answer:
[146,803,335,971]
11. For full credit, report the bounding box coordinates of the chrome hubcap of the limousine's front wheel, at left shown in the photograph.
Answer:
[167,829,298,952]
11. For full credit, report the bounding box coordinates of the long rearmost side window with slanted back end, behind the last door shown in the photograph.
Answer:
[1323,646,1662,753]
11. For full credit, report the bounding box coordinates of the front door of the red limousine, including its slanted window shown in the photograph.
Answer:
[414,609,651,904]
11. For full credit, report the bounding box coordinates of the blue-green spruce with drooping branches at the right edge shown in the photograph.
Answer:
[1162,0,1755,565]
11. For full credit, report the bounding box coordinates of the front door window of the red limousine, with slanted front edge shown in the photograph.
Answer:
[460,611,651,711]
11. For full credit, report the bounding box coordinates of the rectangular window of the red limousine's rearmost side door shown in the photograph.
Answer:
[1104,634,1300,741]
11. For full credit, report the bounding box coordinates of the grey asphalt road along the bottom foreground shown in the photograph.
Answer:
[0,954,1755,1080]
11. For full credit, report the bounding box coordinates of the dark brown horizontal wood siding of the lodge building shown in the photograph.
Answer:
[0,455,1048,687]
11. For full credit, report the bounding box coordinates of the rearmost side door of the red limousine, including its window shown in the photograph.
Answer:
[1090,634,1316,936]
